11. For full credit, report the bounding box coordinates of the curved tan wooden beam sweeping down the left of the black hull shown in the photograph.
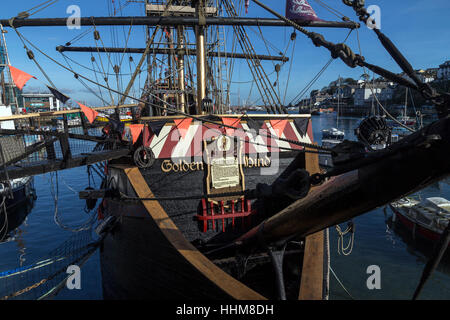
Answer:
[121,166,265,300]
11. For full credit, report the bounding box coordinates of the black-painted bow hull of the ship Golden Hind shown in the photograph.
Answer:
[101,158,316,300]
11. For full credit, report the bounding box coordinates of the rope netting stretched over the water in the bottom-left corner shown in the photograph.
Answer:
[0,229,99,300]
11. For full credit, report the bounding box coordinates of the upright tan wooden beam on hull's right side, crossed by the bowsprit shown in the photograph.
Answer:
[298,144,324,300]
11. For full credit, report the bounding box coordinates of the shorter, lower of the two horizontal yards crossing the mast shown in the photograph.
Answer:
[56,46,289,62]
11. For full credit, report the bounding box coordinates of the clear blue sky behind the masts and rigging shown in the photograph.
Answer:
[0,0,450,105]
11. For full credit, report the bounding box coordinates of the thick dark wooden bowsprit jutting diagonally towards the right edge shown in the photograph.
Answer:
[236,117,450,246]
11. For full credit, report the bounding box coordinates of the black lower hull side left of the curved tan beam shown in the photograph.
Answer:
[100,201,237,300]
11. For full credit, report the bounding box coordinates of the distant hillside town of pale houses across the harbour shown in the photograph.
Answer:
[237,60,450,116]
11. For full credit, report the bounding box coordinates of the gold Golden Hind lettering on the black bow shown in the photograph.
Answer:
[161,156,272,173]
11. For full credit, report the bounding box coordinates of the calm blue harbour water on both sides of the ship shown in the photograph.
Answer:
[0,114,450,299]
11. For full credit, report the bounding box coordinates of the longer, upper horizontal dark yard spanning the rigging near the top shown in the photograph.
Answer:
[0,16,360,29]
